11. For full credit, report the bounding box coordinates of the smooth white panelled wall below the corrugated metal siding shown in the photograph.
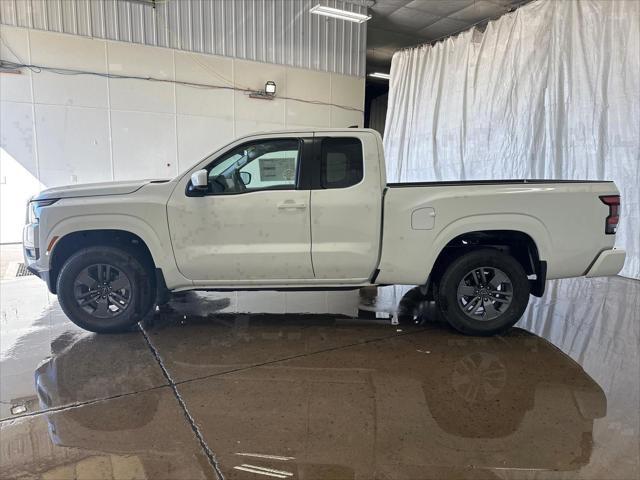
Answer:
[0,25,364,243]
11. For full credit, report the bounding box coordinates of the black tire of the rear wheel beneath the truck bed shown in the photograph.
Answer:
[436,248,529,336]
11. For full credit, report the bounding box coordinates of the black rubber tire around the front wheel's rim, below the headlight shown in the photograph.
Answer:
[57,246,155,333]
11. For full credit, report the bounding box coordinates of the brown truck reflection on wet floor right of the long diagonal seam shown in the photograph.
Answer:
[180,329,606,478]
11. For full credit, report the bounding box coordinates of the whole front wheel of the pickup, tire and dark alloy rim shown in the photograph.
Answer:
[57,246,155,333]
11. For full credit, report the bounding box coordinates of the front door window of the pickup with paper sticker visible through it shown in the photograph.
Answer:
[208,138,300,195]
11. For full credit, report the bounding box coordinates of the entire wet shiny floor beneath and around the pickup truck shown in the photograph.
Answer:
[0,277,640,479]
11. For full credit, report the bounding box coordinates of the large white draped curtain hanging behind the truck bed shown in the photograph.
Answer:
[384,0,640,278]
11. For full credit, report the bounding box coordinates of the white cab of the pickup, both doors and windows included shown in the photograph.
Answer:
[167,130,386,286]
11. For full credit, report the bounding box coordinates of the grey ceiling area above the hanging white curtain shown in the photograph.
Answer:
[367,0,530,73]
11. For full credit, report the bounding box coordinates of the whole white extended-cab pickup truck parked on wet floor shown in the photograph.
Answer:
[24,129,625,335]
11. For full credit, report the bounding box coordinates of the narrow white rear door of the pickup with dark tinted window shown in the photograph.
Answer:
[311,132,384,283]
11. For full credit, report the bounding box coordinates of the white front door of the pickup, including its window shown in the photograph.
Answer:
[167,134,313,284]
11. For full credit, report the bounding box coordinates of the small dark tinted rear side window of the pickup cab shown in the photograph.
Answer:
[320,137,363,188]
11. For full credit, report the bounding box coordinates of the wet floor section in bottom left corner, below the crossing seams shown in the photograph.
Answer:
[0,387,216,480]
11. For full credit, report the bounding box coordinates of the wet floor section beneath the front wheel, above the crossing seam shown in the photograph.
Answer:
[0,278,166,418]
